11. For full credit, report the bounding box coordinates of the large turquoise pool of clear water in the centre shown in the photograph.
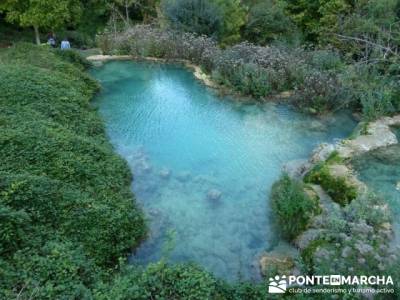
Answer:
[93,62,355,280]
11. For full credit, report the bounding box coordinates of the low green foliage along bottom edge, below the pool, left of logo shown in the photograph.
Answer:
[95,261,278,300]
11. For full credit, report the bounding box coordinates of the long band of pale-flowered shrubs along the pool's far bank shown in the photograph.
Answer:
[99,25,348,113]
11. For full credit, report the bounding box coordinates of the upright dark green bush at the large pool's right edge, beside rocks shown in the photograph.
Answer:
[271,174,320,241]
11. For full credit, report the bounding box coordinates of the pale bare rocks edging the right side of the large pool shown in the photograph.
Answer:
[259,115,400,275]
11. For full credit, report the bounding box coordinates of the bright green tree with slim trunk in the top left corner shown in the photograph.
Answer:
[0,0,82,44]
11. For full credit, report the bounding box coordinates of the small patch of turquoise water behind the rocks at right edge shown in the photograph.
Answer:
[352,141,400,245]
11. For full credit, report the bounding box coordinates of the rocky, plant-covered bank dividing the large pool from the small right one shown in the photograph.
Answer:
[260,115,400,292]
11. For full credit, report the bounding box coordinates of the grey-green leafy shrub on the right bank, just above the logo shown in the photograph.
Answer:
[302,194,400,299]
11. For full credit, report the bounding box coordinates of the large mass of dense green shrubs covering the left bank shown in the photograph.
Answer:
[0,44,145,299]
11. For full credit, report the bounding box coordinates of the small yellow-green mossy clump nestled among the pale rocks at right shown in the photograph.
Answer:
[304,163,357,206]
